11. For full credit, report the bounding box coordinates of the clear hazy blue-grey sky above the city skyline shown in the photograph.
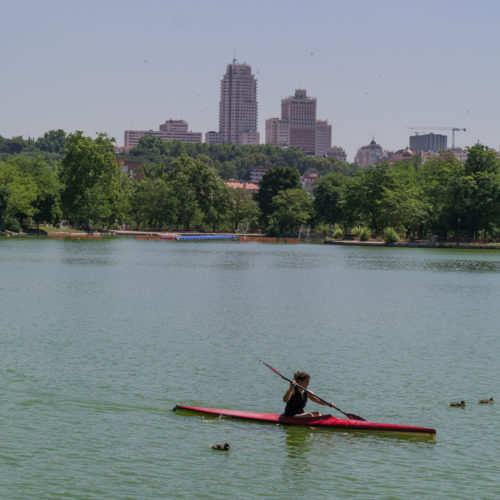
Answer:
[0,0,500,161]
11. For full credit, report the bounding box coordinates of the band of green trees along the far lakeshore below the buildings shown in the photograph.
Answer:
[0,131,500,239]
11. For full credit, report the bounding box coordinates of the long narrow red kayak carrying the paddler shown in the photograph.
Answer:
[174,405,436,438]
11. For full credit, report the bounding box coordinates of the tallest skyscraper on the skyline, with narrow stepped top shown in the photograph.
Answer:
[219,59,259,145]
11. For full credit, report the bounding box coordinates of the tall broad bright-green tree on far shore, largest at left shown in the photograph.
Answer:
[61,131,123,229]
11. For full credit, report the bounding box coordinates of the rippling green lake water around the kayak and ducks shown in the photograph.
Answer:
[0,238,500,499]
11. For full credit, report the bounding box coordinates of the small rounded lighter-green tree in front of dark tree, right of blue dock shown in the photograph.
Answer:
[272,189,312,233]
